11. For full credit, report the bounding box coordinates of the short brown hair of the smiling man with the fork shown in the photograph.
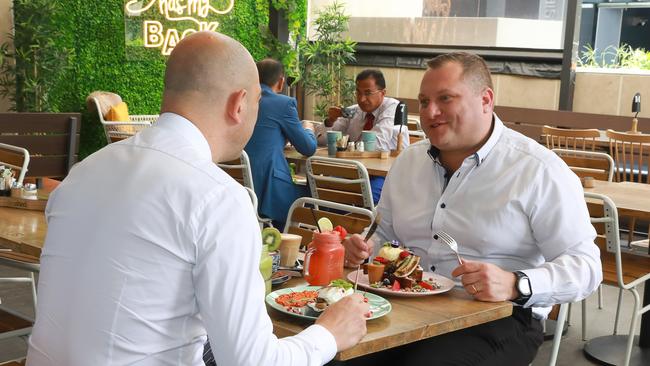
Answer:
[427,52,494,93]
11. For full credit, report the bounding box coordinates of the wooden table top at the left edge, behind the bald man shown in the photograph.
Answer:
[0,207,47,257]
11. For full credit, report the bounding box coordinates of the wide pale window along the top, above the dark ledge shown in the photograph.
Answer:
[308,0,567,50]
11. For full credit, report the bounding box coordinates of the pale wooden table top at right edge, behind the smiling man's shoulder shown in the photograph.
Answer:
[584,180,650,220]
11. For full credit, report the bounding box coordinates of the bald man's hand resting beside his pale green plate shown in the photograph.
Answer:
[316,294,370,352]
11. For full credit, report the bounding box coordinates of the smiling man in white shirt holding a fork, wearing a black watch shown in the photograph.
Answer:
[344,53,602,365]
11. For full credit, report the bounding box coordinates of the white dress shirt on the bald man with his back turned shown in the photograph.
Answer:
[27,113,336,366]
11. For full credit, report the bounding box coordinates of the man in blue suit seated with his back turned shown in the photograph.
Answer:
[244,59,316,230]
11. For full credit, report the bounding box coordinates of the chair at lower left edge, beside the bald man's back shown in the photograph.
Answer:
[0,251,40,340]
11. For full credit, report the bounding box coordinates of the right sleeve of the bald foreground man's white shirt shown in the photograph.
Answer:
[191,189,337,365]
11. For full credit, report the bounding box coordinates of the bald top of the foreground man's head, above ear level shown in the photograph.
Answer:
[164,31,258,102]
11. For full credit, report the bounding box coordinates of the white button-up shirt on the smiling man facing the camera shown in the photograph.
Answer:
[373,116,602,318]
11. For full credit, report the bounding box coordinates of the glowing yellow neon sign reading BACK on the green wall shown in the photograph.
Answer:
[124,0,235,55]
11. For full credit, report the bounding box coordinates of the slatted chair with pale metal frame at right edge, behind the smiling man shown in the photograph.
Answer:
[585,192,650,366]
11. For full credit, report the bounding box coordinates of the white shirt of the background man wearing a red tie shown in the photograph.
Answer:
[318,97,408,151]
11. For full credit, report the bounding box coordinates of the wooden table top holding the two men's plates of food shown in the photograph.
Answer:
[267,278,512,360]
